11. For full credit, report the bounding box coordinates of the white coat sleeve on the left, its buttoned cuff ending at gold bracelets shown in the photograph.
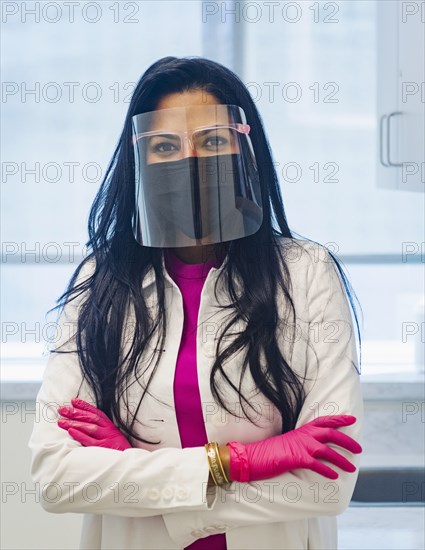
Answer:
[28,260,214,517]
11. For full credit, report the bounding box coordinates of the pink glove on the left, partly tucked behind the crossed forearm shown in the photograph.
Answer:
[58,398,131,451]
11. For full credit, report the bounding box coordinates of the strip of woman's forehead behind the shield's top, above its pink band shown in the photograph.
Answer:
[149,105,232,131]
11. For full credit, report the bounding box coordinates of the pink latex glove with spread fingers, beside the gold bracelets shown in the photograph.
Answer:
[226,414,363,481]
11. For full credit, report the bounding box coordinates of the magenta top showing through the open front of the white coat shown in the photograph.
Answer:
[164,249,227,550]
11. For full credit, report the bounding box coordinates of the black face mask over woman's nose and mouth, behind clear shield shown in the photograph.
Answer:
[141,154,255,242]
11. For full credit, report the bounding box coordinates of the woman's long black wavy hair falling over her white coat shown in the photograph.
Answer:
[49,56,361,443]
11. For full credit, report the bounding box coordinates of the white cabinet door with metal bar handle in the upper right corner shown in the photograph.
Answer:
[377,0,425,192]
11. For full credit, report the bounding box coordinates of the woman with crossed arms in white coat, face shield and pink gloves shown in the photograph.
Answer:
[29,57,363,550]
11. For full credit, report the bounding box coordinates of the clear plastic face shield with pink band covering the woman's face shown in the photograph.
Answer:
[132,105,263,248]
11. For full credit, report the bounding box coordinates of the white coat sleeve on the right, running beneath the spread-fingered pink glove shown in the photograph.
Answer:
[163,245,364,548]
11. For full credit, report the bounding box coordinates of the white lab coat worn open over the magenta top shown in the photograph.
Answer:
[29,239,363,550]
